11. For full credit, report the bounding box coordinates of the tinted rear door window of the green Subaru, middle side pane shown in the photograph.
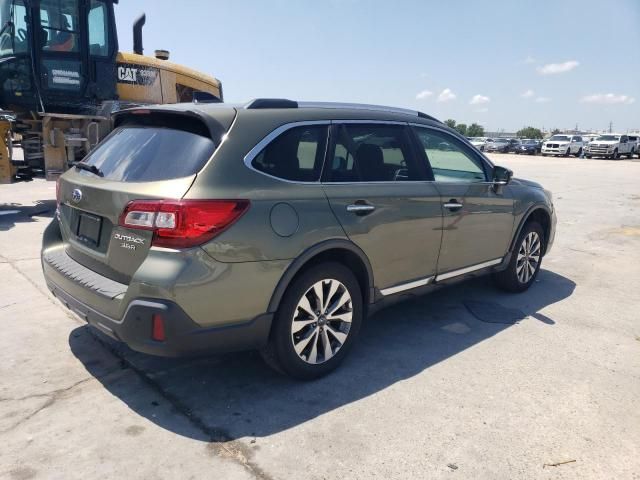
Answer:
[327,124,421,182]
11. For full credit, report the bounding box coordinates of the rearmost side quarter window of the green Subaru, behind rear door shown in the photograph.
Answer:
[251,125,328,182]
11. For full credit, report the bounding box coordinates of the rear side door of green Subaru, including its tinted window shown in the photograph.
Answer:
[323,121,442,295]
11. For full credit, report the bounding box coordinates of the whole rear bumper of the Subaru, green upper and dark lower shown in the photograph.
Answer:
[42,220,278,356]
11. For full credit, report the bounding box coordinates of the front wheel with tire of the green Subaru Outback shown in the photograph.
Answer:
[493,221,545,293]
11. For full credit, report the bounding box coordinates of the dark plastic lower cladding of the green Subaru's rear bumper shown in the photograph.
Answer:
[47,278,273,357]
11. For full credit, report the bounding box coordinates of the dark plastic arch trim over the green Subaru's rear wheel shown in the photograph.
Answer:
[268,239,374,313]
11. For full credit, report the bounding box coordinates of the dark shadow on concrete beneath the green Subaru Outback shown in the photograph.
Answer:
[69,270,575,442]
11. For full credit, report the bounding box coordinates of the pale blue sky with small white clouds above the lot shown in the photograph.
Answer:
[116,0,640,131]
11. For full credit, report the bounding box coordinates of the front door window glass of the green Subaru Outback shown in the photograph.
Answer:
[414,128,487,183]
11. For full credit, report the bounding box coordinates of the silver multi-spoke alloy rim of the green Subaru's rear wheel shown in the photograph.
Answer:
[291,279,353,365]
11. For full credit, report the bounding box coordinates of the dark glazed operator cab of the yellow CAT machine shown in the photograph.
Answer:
[0,0,118,114]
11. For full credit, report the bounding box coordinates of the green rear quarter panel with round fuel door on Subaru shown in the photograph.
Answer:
[185,112,346,262]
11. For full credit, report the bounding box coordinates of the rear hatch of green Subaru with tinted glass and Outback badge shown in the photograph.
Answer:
[58,108,235,284]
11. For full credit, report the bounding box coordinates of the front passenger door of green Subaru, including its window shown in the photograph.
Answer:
[413,125,514,279]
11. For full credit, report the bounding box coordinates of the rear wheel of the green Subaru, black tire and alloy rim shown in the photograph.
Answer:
[262,262,364,380]
